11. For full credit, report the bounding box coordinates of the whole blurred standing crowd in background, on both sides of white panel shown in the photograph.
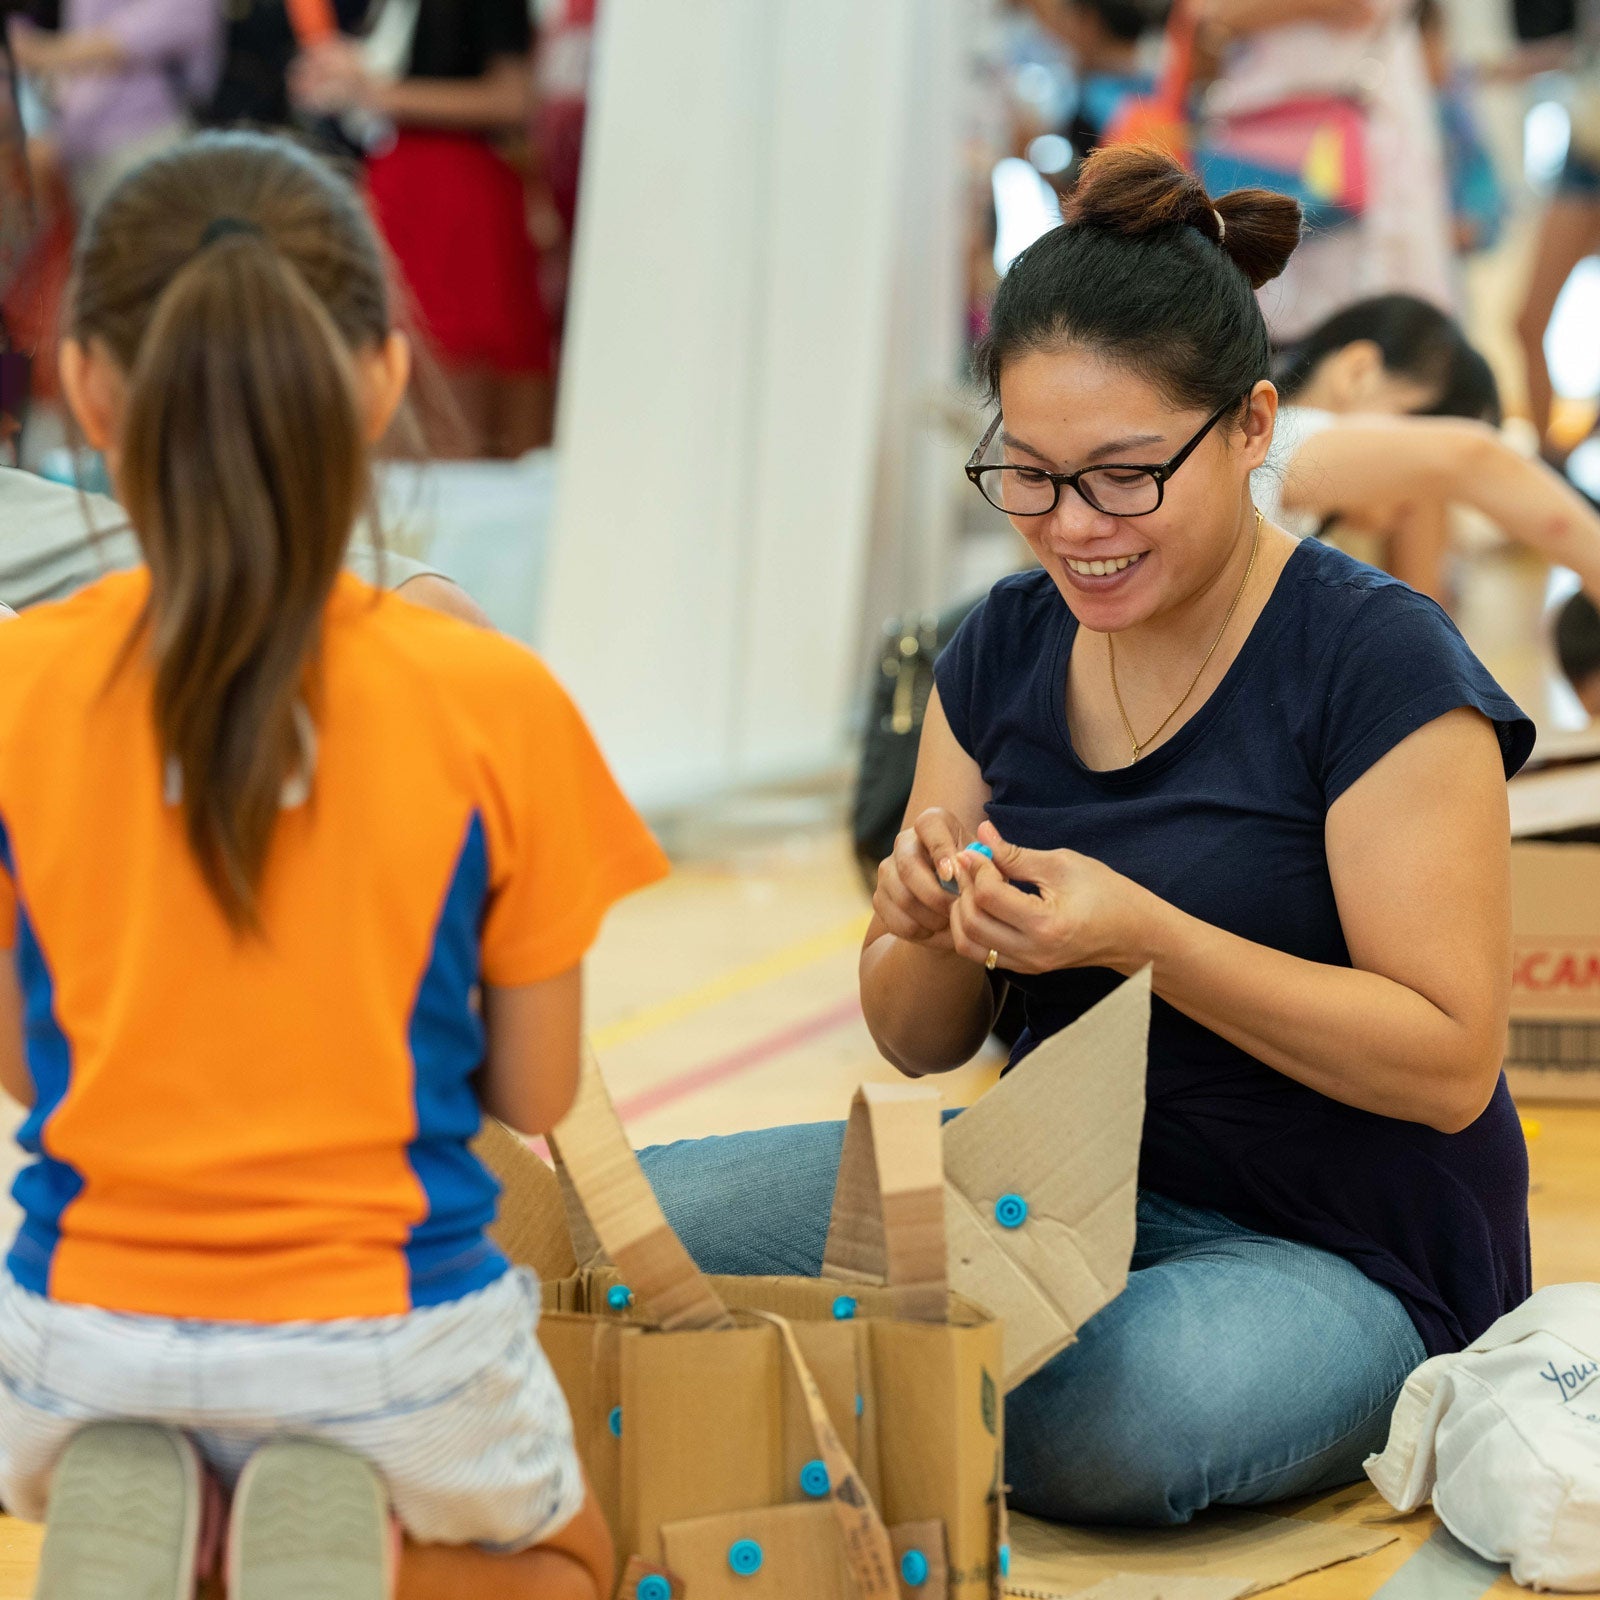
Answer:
[0,0,1600,499]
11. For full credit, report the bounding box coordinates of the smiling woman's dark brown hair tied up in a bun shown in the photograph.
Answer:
[978,146,1301,411]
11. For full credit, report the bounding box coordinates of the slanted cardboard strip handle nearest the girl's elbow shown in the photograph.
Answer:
[550,1050,733,1328]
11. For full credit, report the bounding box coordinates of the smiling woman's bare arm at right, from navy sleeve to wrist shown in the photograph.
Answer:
[1120,709,1510,1133]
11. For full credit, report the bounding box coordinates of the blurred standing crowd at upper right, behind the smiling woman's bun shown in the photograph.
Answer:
[970,0,1600,467]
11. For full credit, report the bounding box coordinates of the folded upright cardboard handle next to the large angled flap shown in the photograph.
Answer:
[822,1083,949,1322]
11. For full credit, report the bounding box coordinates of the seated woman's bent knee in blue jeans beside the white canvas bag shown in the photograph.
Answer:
[1006,1237,1424,1526]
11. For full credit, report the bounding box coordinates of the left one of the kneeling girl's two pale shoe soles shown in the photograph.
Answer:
[34,1422,202,1600]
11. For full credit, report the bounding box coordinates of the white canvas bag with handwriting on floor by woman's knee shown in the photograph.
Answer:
[1366,1283,1600,1594]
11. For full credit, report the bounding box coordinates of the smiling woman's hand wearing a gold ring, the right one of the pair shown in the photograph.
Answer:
[940,819,1158,973]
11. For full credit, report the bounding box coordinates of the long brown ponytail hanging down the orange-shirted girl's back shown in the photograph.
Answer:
[120,229,366,926]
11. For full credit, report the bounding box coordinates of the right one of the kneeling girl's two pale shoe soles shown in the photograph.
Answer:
[227,1438,392,1600]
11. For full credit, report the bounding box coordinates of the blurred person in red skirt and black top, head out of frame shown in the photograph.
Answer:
[291,0,554,456]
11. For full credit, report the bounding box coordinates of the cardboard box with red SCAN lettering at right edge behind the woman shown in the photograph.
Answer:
[1506,762,1600,1104]
